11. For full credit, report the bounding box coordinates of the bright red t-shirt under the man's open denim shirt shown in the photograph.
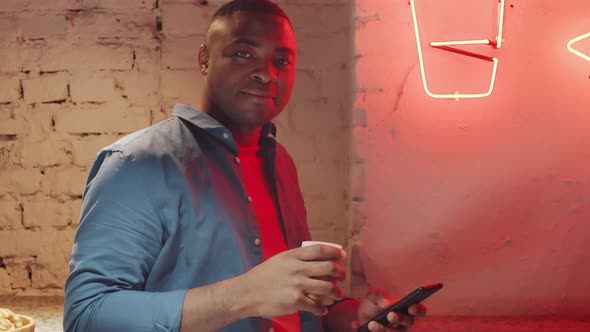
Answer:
[238,144,301,332]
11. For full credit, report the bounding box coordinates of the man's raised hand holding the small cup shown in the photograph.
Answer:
[239,245,345,316]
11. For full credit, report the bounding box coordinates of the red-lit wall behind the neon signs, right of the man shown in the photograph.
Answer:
[352,0,590,315]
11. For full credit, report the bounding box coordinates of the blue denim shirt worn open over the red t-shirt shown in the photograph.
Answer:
[64,104,322,332]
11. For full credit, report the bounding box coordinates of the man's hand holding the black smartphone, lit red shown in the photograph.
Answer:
[352,289,426,332]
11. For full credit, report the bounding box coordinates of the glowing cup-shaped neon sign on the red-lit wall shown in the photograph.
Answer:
[410,0,505,100]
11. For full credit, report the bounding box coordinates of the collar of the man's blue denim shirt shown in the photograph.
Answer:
[172,104,277,154]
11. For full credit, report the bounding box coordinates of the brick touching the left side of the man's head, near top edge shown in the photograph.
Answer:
[162,3,214,37]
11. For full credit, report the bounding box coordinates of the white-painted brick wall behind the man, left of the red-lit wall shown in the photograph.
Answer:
[0,0,353,295]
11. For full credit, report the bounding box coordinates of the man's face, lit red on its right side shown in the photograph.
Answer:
[199,11,297,129]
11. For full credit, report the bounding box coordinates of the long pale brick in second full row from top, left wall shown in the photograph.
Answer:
[39,44,133,72]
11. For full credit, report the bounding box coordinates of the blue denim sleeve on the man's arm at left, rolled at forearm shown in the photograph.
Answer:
[64,151,186,332]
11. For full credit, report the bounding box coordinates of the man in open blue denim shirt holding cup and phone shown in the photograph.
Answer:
[64,0,425,332]
